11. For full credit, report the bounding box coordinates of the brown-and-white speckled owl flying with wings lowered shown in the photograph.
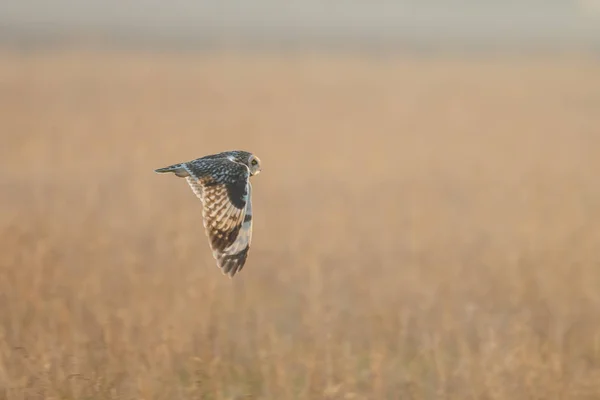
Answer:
[155,150,261,278]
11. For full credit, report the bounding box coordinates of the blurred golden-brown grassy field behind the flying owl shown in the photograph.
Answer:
[0,52,600,400]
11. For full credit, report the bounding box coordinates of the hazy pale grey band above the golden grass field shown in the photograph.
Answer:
[0,0,600,51]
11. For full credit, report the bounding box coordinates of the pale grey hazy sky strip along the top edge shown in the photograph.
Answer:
[0,0,600,47]
